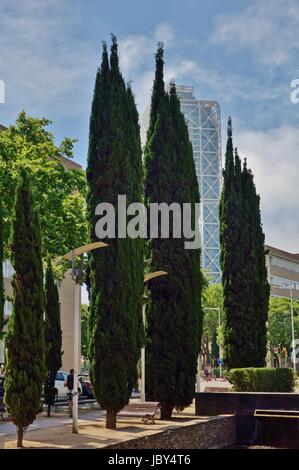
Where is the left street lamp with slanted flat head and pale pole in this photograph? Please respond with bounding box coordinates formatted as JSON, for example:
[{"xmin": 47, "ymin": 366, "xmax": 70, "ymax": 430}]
[{"xmin": 57, "ymin": 242, "xmax": 108, "ymax": 434}]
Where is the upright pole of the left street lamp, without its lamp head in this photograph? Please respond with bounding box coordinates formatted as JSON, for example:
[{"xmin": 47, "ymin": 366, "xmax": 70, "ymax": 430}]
[{"xmin": 72, "ymin": 253, "xmax": 81, "ymax": 434}]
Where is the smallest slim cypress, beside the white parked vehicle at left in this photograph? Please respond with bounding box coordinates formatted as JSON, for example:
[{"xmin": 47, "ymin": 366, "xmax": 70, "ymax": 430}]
[{"xmin": 44, "ymin": 263, "xmax": 62, "ymax": 416}]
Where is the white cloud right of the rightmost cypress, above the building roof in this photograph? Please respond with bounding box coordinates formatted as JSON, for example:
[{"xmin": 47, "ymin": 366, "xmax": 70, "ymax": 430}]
[{"xmin": 235, "ymin": 126, "xmax": 299, "ymax": 253}]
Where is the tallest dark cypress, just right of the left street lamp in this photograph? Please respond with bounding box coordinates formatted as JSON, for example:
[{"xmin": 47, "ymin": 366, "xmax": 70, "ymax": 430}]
[{"xmin": 87, "ymin": 37, "xmax": 143, "ymax": 428}]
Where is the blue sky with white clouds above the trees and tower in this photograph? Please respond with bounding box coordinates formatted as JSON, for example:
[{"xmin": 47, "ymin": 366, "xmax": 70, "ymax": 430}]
[{"xmin": 0, "ymin": 0, "xmax": 299, "ymax": 253}]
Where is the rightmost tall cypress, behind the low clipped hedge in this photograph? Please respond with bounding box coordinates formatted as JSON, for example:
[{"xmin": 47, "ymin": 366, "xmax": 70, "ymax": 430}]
[{"xmin": 220, "ymin": 118, "xmax": 269, "ymax": 369}]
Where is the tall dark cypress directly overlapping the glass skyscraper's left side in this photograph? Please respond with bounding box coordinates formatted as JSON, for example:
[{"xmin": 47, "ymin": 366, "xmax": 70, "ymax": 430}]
[{"xmin": 145, "ymin": 44, "xmax": 202, "ymax": 418}]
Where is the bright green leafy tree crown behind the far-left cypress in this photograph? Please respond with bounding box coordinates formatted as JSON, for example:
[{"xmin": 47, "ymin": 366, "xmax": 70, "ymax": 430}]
[{"xmin": 0, "ymin": 112, "xmax": 87, "ymax": 258}]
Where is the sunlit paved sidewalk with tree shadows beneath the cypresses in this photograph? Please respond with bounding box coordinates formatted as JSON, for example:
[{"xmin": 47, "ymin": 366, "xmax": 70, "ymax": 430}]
[{"xmin": 0, "ymin": 405, "xmax": 224, "ymax": 449}]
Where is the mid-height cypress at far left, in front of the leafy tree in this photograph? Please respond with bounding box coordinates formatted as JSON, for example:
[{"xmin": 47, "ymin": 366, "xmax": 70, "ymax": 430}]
[{"xmin": 4, "ymin": 170, "xmax": 46, "ymax": 447}]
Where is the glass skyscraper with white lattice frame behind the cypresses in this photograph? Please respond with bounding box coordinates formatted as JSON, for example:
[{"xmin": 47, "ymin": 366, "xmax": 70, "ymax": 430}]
[{"xmin": 176, "ymin": 85, "xmax": 222, "ymax": 282}]
